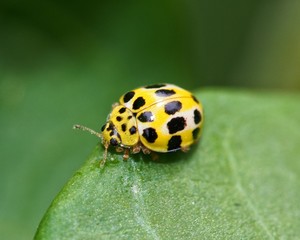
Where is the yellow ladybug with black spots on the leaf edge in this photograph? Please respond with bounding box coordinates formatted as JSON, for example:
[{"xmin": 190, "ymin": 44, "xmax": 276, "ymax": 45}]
[{"xmin": 74, "ymin": 84, "xmax": 203, "ymax": 165}]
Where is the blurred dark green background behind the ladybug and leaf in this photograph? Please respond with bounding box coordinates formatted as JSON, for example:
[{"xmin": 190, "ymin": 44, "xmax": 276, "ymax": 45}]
[{"xmin": 0, "ymin": 0, "xmax": 300, "ymax": 239}]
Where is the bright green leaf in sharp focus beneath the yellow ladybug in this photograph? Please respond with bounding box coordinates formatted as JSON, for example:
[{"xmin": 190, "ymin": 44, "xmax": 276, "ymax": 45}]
[{"xmin": 35, "ymin": 90, "xmax": 300, "ymax": 239}]
